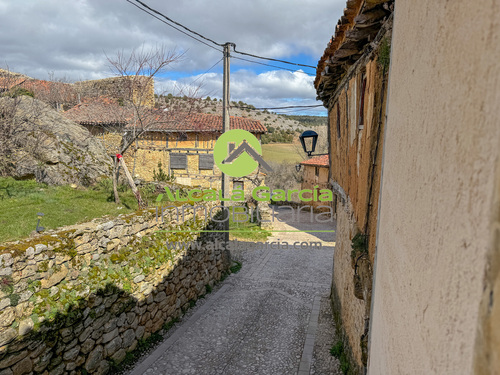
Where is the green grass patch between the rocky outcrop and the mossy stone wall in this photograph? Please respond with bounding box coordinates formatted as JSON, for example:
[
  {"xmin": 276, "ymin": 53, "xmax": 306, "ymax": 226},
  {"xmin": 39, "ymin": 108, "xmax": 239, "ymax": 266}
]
[{"xmin": 0, "ymin": 178, "xmax": 157, "ymax": 242}]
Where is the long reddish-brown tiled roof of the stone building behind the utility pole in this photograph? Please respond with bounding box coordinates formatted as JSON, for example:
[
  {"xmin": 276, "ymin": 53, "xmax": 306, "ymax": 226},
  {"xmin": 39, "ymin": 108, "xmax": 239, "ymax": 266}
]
[{"xmin": 64, "ymin": 101, "xmax": 267, "ymax": 133}]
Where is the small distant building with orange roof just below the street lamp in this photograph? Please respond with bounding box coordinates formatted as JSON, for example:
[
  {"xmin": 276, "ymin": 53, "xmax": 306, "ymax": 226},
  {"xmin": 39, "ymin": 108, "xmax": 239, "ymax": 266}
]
[{"xmin": 300, "ymin": 155, "xmax": 335, "ymax": 211}]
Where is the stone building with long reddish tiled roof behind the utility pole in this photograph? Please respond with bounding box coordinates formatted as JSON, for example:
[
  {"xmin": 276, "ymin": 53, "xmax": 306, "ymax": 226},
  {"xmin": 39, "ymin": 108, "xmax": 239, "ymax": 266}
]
[{"xmin": 65, "ymin": 98, "xmax": 267, "ymax": 190}]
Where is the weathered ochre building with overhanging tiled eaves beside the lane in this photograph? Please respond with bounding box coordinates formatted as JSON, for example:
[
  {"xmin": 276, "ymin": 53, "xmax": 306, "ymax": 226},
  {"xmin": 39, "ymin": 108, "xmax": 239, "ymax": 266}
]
[{"xmin": 315, "ymin": 0, "xmax": 393, "ymax": 372}]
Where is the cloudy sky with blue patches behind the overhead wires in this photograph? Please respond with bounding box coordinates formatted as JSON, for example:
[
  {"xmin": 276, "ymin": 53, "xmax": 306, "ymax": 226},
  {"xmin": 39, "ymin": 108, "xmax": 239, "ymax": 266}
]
[{"xmin": 0, "ymin": 0, "xmax": 345, "ymax": 115}]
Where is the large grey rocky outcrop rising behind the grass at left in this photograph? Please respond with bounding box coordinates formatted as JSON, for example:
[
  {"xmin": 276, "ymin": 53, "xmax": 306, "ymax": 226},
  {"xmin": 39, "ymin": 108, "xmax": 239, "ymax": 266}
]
[{"xmin": 0, "ymin": 96, "xmax": 112, "ymax": 186}]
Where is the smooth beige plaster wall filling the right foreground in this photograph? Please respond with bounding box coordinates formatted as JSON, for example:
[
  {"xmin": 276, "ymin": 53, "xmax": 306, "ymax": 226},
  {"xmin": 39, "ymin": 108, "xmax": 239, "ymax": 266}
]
[{"xmin": 369, "ymin": 0, "xmax": 500, "ymax": 375}]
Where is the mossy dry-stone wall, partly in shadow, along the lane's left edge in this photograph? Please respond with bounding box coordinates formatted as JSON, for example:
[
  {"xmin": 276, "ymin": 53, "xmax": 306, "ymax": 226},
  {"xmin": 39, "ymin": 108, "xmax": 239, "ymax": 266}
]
[{"xmin": 0, "ymin": 210, "xmax": 229, "ymax": 375}]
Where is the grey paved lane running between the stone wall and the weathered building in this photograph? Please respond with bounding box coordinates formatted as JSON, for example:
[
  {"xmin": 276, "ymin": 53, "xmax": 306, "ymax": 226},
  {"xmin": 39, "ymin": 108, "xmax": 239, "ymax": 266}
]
[{"xmin": 130, "ymin": 207, "xmax": 335, "ymax": 375}]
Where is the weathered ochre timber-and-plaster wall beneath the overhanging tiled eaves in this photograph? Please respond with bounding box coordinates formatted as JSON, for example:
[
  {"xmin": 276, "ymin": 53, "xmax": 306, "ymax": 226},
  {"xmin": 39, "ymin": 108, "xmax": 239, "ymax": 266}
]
[{"xmin": 328, "ymin": 28, "xmax": 391, "ymax": 372}]
